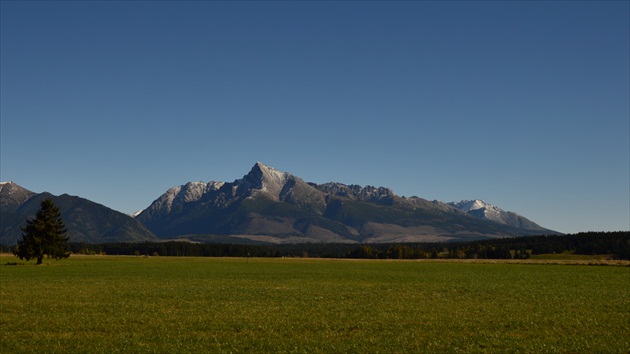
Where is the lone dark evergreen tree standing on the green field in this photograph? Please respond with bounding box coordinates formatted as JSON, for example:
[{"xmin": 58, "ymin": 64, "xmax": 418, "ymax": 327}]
[{"xmin": 14, "ymin": 199, "xmax": 70, "ymax": 264}]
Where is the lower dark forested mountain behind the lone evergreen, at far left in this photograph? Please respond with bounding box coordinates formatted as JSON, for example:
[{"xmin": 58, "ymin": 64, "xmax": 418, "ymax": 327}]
[{"xmin": 0, "ymin": 183, "xmax": 157, "ymax": 245}]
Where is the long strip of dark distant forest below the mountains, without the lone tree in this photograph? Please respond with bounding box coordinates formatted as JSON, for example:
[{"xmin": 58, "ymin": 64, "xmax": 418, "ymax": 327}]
[{"xmin": 0, "ymin": 231, "xmax": 630, "ymax": 259}]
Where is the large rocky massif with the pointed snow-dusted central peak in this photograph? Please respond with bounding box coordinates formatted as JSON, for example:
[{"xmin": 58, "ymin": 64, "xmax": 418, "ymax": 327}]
[{"xmin": 136, "ymin": 163, "xmax": 554, "ymax": 243}]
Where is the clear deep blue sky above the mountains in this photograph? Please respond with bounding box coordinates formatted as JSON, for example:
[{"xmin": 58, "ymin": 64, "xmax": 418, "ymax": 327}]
[{"xmin": 0, "ymin": 1, "xmax": 630, "ymax": 232}]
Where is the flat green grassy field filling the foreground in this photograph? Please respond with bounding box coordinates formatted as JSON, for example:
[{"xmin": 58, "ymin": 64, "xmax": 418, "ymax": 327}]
[{"xmin": 0, "ymin": 256, "xmax": 630, "ymax": 353}]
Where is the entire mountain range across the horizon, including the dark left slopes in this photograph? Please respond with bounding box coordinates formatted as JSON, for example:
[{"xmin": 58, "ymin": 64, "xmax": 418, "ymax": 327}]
[{"xmin": 0, "ymin": 162, "xmax": 557, "ymax": 244}]
